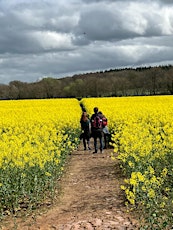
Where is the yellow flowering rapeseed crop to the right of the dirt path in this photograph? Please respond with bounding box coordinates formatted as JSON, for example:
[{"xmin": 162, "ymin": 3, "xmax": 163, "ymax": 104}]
[{"xmin": 81, "ymin": 96, "xmax": 173, "ymax": 230}]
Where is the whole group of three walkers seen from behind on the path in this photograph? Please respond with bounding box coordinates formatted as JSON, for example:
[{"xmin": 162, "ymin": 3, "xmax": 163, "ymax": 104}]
[{"xmin": 80, "ymin": 107, "xmax": 110, "ymax": 153}]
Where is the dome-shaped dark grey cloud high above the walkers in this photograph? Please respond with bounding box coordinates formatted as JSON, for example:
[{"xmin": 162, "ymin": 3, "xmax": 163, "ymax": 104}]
[{"xmin": 73, "ymin": 9, "xmax": 141, "ymax": 44}]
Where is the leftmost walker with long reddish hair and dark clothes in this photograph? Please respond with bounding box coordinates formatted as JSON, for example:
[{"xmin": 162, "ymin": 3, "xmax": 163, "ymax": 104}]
[{"xmin": 80, "ymin": 111, "xmax": 91, "ymax": 150}]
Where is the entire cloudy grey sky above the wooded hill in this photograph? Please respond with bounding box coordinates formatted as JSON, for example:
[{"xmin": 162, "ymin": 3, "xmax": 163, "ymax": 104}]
[{"xmin": 0, "ymin": 0, "xmax": 173, "ymax": 84}]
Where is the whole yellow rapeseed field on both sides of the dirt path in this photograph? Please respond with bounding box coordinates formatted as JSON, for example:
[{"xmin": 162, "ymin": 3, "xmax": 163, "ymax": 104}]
[{"xmin": 0, "ymin": 96, "xmax": 173, "ymax": 229}]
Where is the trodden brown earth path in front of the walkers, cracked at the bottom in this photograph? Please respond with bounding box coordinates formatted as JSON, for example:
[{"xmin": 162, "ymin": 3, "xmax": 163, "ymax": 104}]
[{"xmin": 1, "ymin": 143, "xmax": 139, "ymax": 230}]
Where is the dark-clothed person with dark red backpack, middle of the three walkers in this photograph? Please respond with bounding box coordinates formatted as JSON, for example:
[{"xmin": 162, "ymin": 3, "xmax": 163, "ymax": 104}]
[{"xmin": 91, "ymin": 107, "xmax": 103, "ymax": 153}]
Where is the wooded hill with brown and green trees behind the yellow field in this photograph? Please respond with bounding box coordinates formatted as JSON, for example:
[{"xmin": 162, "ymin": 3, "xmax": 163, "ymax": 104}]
[{"xmin": 0, "ymin": 65, "xmax": 173, "ymax": 99}]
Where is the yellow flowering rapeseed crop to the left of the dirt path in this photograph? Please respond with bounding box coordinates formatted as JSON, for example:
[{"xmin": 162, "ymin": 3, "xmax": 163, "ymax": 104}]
[{"xmin": 0, "ymin": 99, "xmax": 81, "ymax": 217}]
